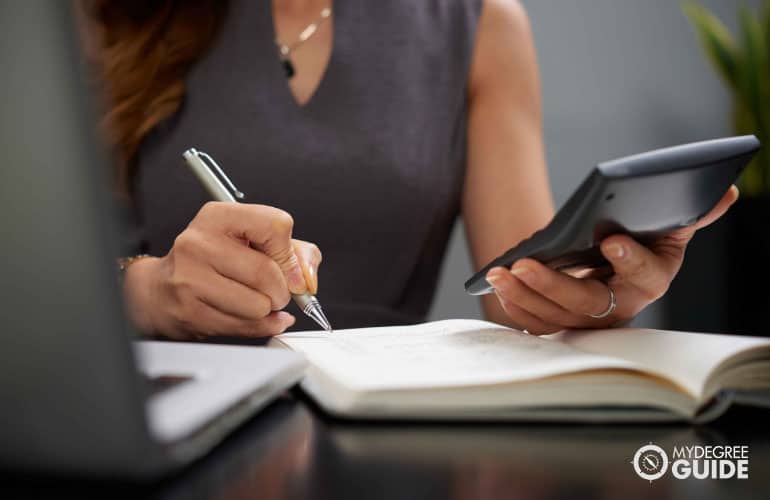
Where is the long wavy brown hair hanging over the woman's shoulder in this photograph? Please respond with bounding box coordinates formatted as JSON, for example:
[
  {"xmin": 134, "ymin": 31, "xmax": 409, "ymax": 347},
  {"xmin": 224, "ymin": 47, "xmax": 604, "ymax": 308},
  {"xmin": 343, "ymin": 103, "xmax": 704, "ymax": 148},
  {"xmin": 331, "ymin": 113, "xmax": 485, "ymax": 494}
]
[{"xmin": 77, "ymin": 0, "xmax": 227, "ymax": 195}]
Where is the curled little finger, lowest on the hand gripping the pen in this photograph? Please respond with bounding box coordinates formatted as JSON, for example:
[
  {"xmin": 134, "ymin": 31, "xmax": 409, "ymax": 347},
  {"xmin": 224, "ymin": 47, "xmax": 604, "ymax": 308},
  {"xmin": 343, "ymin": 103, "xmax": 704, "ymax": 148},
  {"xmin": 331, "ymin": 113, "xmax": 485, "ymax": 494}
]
[{"xmin": 184, "ymin": 301, "xmax": 296, "ymax": 338}]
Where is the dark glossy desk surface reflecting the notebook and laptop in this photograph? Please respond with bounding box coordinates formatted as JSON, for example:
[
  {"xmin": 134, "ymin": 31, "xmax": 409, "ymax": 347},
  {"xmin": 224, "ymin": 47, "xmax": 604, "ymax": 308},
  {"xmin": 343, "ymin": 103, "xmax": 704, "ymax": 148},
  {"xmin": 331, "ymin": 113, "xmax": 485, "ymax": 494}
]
[{"xmin": 6, "ymin": 395, "xmax": 770, "ymax": 500}]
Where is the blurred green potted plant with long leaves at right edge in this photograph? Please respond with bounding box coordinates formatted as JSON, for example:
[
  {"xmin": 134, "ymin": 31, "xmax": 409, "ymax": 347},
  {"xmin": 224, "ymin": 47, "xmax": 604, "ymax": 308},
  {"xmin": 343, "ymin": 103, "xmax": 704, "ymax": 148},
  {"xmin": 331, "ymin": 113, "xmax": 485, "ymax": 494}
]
[{"xmin": 682, "ymin": 0, "xmax": 770, "ymax": 196}]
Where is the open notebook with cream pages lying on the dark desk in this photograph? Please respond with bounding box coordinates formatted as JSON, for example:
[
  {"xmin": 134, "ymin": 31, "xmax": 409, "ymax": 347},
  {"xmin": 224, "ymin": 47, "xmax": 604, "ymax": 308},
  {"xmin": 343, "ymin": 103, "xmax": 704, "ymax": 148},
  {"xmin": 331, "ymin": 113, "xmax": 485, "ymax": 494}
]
[{"xmin": 271, "ymin": 320, "xmax": 770, "ymax": 421}]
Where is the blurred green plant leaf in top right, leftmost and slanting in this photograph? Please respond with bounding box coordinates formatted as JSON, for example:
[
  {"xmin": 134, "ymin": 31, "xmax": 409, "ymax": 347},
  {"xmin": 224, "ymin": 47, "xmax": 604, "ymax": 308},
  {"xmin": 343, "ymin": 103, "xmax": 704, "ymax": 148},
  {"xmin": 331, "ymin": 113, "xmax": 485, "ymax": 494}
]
[{"xmin": 682, "ymin": 1, "xmax": 740, "ymax": 90}]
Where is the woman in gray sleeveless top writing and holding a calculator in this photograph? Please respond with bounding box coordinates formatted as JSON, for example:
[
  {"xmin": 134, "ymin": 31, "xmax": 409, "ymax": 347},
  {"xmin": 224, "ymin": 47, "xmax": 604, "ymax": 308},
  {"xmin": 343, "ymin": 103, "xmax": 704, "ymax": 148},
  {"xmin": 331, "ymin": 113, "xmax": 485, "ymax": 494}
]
[{"xmin": 76, "ymin": 0, "xmax": 737, "ymax": 338}]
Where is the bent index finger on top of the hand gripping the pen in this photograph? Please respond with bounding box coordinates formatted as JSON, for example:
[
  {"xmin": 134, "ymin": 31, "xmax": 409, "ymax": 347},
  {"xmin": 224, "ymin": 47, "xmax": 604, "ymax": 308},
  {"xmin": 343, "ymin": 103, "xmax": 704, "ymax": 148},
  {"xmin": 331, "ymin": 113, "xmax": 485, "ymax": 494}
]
[{"xmin": 193, "ymin": 202, "xmax": 307, "ymax": 293}]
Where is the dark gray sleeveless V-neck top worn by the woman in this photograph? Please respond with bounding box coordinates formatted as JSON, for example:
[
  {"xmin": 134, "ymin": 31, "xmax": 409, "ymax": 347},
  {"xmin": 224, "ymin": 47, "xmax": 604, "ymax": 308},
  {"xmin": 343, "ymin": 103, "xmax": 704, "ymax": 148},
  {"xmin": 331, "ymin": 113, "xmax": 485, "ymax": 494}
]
[{"xmin": 134, "ymin": 0, "xmax": 481, "ymax": 330}]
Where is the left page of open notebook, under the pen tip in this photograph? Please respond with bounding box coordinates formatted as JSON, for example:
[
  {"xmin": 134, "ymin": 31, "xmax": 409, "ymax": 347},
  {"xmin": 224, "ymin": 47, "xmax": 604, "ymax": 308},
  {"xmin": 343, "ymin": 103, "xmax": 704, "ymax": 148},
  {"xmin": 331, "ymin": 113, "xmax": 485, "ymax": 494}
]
[{"xmin": 276, "ymin": 320, "xmax": 633, "ymax": 390}]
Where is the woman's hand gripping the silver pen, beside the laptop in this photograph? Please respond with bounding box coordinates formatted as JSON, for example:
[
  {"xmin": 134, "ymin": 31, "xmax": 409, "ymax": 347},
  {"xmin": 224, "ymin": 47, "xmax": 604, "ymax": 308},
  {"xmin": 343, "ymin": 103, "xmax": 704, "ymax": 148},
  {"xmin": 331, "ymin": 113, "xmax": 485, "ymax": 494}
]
[{"xmin": 123, "ymin": 202, "xmax": 321, "ymax": 339}]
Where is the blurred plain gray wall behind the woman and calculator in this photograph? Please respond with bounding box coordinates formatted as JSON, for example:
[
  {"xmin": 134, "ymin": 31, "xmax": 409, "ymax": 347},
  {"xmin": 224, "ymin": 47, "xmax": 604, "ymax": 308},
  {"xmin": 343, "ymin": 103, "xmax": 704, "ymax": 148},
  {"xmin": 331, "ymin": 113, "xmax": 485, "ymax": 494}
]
[{"xmin": 431, "ymin": 0, "xmax": 758, "ymax": 328}]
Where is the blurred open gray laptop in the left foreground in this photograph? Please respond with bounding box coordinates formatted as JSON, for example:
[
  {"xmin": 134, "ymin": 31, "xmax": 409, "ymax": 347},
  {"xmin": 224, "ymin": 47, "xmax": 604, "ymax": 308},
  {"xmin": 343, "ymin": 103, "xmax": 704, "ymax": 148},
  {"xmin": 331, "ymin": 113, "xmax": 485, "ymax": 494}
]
[{"xmin": 0, "ymin": 1, "xmax": 305, "ymax": 478}]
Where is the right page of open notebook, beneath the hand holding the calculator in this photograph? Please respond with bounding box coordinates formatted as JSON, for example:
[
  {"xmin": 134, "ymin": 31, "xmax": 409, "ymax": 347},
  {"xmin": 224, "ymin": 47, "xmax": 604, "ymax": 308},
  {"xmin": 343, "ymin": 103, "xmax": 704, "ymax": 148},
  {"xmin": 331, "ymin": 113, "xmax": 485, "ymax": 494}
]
[{"xmin": 547, "ymin": 328, "xmax": 770, "ymax": 397}]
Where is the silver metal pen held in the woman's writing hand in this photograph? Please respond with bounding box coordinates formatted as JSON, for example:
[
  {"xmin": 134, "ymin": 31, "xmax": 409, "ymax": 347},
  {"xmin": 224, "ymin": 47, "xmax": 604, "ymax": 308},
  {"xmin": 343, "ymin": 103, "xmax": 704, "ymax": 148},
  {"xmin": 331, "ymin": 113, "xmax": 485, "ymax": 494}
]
[{"xmin": 182, "ymin": 148, "xmax": 332, "ymax": 332}]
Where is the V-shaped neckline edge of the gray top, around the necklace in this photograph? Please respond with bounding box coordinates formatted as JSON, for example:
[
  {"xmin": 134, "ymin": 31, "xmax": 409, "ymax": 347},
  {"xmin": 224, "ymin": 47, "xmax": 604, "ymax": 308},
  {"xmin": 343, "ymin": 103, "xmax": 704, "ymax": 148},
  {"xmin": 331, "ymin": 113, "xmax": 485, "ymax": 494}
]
[{"xmin": 267, "ymin": 0, "xmax": 343, "ymax": 111}]
